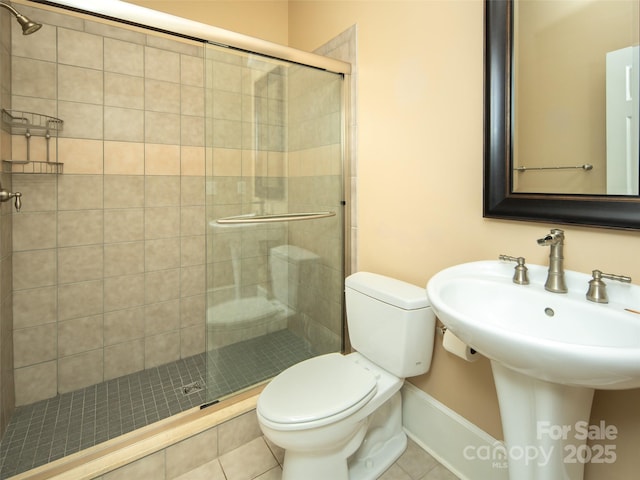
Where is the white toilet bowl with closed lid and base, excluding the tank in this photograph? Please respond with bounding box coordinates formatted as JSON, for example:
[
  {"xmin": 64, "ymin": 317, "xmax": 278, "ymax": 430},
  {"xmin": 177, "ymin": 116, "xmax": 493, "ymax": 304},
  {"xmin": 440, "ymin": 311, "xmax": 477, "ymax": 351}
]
[{"xmin": 257, "ymin": 352, "xmax": 406, "ymax": 479}]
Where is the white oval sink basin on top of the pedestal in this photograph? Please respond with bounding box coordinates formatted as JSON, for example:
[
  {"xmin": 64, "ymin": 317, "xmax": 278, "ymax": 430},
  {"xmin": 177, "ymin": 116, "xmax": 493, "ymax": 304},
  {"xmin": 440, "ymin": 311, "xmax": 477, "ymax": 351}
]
[{"xmin": 427, "ymin": 261, "xmax": 640, "ymax": 390}]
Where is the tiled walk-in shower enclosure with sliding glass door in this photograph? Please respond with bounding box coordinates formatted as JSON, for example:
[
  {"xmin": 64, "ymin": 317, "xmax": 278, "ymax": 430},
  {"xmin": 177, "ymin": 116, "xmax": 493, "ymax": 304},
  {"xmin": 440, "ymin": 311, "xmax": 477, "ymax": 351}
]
[{"xmin": 0, "ymin": 0, "xmax": 346, "ymax": 478}]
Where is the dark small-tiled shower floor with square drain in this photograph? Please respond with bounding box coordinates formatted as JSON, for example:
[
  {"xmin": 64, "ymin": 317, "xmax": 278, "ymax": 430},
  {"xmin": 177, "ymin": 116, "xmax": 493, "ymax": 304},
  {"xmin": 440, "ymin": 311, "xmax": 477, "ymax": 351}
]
[{"xmin": 0, "ymin": 330, "xmax": 313, "ymax": 478}]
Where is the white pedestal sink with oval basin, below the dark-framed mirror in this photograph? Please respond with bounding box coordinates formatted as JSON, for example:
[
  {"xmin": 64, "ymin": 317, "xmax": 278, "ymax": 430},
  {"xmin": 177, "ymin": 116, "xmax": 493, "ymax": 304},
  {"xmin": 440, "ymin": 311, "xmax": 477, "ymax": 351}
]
[{"xmin": 427, "ymin": 261, "xmax": 640, "ymax": 480}]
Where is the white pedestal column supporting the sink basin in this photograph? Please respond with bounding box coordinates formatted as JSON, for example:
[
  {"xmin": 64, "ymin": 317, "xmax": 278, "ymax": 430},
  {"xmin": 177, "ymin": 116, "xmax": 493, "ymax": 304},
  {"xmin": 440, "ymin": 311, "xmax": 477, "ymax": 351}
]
[{"xmin": 491, "ymin": 360, "xmax": 594, "ymax": 480}]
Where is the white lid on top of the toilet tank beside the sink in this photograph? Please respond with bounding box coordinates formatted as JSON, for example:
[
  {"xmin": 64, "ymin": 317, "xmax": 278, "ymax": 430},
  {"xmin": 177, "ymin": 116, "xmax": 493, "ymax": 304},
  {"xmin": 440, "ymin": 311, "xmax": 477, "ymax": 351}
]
[{"xmin": 345, "ymin": 272, "xmax": 429, "ymax": 310}]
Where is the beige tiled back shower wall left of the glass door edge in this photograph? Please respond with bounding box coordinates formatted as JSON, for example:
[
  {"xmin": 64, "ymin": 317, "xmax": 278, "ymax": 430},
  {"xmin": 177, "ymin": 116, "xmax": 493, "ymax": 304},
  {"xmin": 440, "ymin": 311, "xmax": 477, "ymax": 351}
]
[{"xmin": 9, "ymin": 6, "xmax": 205, "ymax": 405}]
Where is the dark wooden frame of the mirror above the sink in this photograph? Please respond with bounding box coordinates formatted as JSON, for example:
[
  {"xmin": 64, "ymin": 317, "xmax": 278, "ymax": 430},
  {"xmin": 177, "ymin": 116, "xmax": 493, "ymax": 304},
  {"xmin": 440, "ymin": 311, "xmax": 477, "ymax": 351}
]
[{"xmin": 483, "ymin": 0, "xmax": 640, "ymax": 230}]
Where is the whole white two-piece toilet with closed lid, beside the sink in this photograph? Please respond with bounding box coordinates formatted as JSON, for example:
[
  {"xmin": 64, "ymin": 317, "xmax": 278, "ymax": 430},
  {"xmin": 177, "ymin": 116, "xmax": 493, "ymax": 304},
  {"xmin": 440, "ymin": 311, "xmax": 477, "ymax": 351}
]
[{"xmin": 257, "ymin": 272, "xmax": 435, "ymax": 480}]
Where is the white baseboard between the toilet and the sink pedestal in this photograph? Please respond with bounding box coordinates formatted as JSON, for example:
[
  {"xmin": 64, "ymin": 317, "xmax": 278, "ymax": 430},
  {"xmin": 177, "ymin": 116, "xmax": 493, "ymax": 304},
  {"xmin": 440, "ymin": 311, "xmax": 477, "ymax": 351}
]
[{"xmin": 402, "ymin": 382, "xmax": 509, "ymax": 480}]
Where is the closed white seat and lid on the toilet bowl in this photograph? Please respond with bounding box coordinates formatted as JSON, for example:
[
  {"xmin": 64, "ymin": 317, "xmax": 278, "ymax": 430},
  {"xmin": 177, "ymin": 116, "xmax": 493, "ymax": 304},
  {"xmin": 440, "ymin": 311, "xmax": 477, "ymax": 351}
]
[{"xmin": 257, "ymin": 353, "xmax": 377, "ymax": 430}]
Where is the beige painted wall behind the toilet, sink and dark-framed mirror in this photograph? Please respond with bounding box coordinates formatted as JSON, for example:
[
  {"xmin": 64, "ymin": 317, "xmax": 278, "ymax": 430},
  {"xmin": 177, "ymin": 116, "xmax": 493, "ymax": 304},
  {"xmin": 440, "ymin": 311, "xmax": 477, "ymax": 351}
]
[{"xmin": 289, "ymin": 0, "xmax": 640, "ymax": 479}]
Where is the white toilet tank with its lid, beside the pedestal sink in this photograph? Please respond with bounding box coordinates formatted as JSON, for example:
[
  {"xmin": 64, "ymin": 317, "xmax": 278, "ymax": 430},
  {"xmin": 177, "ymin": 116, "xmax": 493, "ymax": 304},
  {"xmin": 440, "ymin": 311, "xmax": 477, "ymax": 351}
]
[{"xmin": 345, "ymin": 272, "xmax": 436, "ymax": 378}]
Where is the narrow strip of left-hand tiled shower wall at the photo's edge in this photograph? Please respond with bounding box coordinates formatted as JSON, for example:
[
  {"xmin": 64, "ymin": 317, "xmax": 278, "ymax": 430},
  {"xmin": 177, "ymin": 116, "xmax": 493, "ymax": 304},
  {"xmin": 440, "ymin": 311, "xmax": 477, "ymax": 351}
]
[{"xmin": 0, "ymin": 5, "xmax": 15, "ymax": 436}]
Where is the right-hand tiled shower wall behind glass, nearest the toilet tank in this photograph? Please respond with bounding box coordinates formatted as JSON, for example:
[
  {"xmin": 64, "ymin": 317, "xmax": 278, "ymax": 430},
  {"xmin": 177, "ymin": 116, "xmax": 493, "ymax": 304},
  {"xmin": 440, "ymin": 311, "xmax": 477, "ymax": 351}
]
[{"xmin": 288, "ymin": 67, "xmax": 344, "ymax": 352}]
